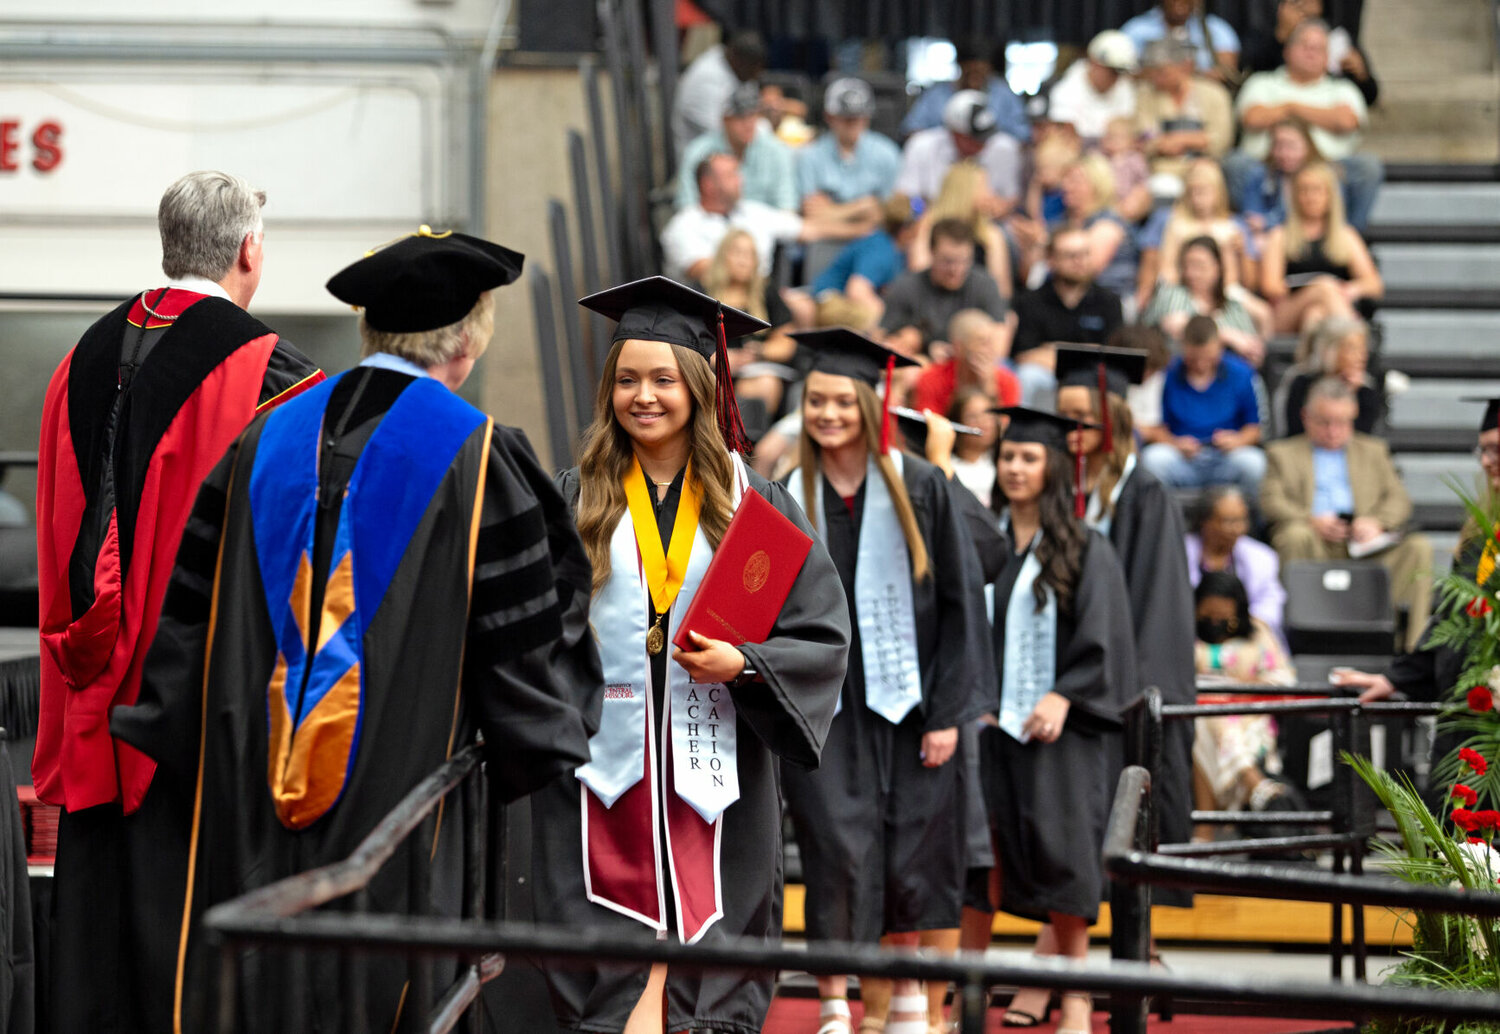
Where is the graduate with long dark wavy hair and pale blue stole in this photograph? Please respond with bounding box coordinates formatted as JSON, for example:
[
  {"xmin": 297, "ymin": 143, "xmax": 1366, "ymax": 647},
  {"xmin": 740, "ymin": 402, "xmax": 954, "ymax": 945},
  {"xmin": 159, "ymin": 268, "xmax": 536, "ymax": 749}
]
[{"xmin": 986, "ymin": 407, "xmax": 1136, "ymax": 1034}]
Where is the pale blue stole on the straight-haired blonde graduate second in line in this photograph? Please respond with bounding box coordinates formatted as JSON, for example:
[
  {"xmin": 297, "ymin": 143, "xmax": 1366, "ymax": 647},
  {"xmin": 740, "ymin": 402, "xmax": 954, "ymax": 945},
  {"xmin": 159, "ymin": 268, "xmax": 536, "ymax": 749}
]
[{"xmin": 789, "ymin": 452, "xmax": 923, "ymax": 725}]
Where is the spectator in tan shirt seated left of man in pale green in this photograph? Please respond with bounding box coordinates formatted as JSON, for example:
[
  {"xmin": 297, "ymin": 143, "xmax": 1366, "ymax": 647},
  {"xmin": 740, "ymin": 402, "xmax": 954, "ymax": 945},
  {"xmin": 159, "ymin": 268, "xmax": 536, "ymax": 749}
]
[{"xmin": 1136, "ymin": 39, "xmax": 1235, "ymax": 186}]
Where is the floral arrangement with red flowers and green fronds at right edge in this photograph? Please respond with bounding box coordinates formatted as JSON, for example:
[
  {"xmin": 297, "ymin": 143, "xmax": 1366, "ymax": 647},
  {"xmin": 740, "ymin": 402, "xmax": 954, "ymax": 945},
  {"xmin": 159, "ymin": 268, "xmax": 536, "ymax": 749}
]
[{"xmin": 1347, "ymin": 485, "xmax": 1500, "ymax": 1034}]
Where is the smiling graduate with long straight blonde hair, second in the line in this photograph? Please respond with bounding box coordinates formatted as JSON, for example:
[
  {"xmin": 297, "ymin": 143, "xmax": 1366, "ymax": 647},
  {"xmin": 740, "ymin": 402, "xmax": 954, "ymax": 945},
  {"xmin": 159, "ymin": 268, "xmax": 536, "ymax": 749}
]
[{"xmin": 783, "ymin": 329, "xmax": 995, "ymax": 1034}]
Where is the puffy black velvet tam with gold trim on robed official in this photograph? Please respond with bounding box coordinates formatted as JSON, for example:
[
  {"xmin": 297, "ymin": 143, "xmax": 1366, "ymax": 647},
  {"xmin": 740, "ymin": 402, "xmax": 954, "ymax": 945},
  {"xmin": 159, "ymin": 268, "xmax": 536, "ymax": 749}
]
[{"xmin": 327, "ymin": 227, "xmax": 527, "ymax": 333}]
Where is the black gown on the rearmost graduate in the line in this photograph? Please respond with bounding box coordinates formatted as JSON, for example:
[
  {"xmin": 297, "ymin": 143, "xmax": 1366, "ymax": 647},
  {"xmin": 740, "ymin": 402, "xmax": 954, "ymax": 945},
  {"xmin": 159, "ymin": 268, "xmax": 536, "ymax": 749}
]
[{"xmin": 1110, "ymin": 464, "xmax": 1197, "ymax": 908}]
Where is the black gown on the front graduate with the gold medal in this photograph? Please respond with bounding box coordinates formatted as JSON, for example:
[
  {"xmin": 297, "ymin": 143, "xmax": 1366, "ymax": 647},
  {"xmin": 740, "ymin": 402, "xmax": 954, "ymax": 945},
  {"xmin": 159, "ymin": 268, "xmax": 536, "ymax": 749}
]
[{"xmin": 531, "ymin": 470, "xmax": 849, "ymax": 1034}]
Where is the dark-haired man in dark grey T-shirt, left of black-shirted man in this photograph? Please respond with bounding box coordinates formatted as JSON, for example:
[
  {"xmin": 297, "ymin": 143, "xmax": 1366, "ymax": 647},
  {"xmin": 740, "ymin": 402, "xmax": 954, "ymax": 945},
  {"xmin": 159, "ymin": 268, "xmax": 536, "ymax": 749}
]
[{"xmin": 881, "ymin": 219, "xmax": 1010, "ymax": 354}]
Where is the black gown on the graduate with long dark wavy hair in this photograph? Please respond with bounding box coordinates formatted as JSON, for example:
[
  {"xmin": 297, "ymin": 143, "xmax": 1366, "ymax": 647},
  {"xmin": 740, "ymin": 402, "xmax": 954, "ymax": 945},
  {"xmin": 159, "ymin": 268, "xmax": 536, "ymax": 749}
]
[{"xmin": 984, "ymin": 531, "xmax": 1136, "ymax": 923}]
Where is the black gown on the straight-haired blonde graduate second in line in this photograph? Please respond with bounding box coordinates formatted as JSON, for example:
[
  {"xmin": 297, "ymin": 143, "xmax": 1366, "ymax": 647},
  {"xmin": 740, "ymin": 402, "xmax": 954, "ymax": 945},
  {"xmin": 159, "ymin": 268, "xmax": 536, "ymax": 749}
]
[{"xmin": 783, "ymin": 456, "xmax": 996, "ymax": 941}]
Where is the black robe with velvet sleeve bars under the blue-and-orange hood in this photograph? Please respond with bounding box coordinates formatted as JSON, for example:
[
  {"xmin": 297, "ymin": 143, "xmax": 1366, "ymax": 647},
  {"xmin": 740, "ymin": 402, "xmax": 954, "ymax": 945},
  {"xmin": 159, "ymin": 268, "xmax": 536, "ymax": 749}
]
[{"xmin": 111, "ymin": 368, "xmax": 602, "ymax": 1031}]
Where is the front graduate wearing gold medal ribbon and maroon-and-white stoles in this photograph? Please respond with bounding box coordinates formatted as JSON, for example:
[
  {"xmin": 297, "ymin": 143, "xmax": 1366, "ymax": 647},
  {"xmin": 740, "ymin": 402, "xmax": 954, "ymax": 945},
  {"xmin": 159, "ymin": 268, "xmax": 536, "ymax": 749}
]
[{"xmin": 531, "ymin": 276, "xmax": 849, "ymax": 1034}]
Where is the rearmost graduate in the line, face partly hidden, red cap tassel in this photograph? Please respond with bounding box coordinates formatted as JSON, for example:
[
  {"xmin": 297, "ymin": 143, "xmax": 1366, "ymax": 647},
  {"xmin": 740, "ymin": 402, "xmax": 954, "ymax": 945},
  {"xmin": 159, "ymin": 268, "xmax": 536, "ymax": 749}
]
[{"xmin": 1058, "ymin": 345, "xmax": 1197, "ymax": 908}]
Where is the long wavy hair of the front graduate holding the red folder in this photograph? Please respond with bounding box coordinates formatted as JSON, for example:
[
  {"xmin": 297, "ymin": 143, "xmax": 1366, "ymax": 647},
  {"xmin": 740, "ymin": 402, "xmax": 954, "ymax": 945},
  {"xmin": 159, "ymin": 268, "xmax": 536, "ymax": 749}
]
[{"xmin": 575, "ymin": 341, "xmax": 735, "ymax": 596}]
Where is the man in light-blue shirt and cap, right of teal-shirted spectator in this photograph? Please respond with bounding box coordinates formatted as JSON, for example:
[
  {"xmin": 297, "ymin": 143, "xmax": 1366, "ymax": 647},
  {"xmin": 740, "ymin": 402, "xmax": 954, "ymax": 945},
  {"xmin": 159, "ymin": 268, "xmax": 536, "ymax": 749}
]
[{"xmin": 797, "ymin": 78, "xmax": 902, "ymax": 228}]
